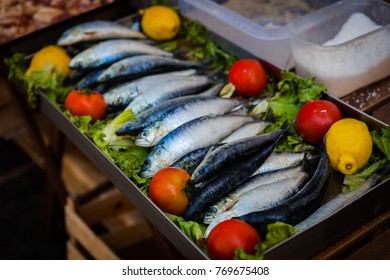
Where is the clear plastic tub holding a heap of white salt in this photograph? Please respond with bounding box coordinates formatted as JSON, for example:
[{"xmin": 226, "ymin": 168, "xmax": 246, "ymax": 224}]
[{"xmin": 288, "ymin": 0, "xmax": 390, "ymax": 98}]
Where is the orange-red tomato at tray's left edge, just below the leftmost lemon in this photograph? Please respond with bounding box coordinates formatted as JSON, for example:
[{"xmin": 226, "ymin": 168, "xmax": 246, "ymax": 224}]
[{"xmin": 65, "ymin": 89, "xmax": 107, "ymax": 122}]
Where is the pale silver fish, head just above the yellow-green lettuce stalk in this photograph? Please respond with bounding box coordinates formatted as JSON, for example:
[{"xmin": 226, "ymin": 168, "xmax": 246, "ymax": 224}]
[{"xmin": 125, "ymin": 75, "xmax": 211, "ymax": 115}]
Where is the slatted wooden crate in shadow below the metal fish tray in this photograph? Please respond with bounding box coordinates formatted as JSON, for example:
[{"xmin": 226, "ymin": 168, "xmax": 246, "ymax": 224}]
[{"xmin": 65, "ymin": 192, "xmax": 152, "ymax": 260}]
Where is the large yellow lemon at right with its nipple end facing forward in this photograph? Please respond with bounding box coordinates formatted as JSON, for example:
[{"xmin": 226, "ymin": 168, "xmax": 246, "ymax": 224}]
[{"xmin": 326, "ymin": 118, "xmax": 373, "ymax": 175}]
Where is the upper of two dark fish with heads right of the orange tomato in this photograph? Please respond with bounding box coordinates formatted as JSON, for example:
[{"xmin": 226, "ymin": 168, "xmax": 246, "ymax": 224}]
[{"xmin": 191, "ymin": 129, "xmax": 284, "ymax": 184}]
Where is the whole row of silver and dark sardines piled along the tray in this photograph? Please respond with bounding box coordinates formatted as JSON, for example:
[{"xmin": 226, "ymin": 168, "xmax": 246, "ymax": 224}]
[{"xmin": 58, "ymin": 18, "xmax": 336, "ymax": 236}]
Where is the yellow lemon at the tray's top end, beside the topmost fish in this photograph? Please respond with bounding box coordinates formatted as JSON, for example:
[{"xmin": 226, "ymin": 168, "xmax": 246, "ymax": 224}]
[{"xmin": 140, "ymin": 5, "xmax": 180, "ymax": 41}]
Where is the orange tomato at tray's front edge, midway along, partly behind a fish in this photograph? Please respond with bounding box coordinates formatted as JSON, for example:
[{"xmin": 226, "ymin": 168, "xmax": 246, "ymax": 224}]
[{"xmin": 149, "ymin": 167, "xmax": 190, "ymax": 216}]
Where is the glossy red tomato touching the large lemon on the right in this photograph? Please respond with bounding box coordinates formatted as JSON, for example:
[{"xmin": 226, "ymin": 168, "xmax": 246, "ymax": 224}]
[{"xmin": 295, "ymin": 100, "xmax": 343, "ymax": 145}]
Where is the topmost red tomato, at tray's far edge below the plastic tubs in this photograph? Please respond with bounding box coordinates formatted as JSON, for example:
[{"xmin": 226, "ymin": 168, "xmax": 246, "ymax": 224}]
[{"xmin": 228, "ymin": 58, "xmax": 267, "ymax": 96}]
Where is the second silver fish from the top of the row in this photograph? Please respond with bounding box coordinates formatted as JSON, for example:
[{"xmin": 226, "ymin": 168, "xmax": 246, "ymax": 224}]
[{"xmin": 69, "ymin": 39, "xmax": 173, "ymax": 69}]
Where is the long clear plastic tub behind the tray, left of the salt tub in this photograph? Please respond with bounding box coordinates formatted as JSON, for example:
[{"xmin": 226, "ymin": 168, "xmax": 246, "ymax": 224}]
[{"xmin": 179, "ymin": 0, "xmax": 335, "ymax": 69}]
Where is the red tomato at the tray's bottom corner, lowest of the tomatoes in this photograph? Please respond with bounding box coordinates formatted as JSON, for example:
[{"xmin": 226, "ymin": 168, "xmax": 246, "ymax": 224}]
[{"xmin": 206, "ymin": 219, "xmax": 261, "ymax": 260}]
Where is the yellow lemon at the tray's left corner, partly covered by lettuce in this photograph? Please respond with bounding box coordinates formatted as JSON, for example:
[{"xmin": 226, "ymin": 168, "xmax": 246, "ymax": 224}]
[{"xmin": 26, "ymin": 46, "xmax": 71, "ymax": 76}]
